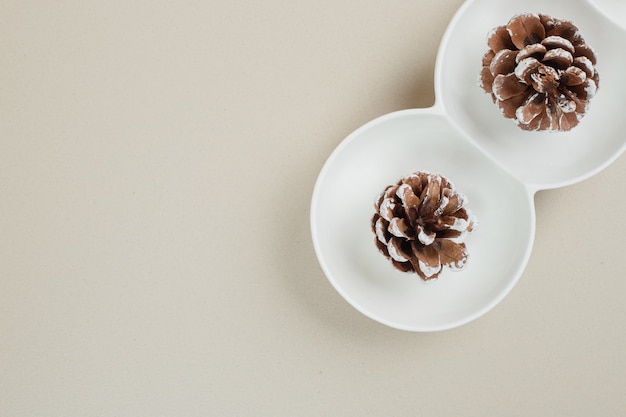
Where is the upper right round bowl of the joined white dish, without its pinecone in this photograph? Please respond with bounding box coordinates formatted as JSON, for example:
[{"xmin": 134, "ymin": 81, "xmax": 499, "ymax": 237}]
[{"xmin": 435, "ymin": 0, "xmax": 626, "ymax": 189}]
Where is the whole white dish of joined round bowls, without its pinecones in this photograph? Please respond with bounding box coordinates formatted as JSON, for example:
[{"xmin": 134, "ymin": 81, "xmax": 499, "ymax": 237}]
[{"xmin": 311, "ymin": 0, "xmax": 626, "ymax": 331}]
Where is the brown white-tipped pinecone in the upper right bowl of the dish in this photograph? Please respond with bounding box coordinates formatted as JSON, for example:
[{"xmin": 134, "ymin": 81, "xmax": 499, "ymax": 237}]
[{"xmin": 480, "ymin": 13, "xmax": 599, "ymax": 131}]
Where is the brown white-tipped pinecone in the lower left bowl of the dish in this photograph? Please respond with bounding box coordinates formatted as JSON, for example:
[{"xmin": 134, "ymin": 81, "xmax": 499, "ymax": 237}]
[{"xmin": 372, "ymin": 171, "xmax": 475, "ymax": 281}]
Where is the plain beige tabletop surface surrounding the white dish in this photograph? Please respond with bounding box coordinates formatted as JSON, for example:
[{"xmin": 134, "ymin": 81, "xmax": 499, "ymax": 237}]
[{"xmin": 0, "ymin": 0, "xmax": 626, "ymax": 417}]
